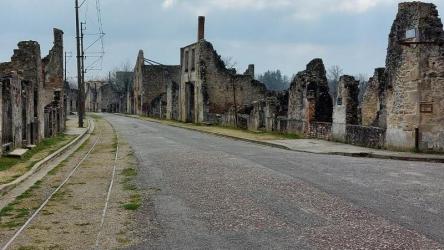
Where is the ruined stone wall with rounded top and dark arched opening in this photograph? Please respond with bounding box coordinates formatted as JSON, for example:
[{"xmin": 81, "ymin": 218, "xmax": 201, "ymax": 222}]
[{"xmin": 288, "ymin": 59, "xmax": 333, "ymax": 133}]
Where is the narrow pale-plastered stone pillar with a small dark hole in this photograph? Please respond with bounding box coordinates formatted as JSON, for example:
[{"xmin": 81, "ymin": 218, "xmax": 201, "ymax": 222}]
[{"xmin": 332, "ymin": 75, "xmax": 359, "ymax": 141}]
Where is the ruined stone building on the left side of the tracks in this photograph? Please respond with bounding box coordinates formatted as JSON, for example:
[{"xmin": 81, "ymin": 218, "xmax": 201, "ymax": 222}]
[{"xmin": 0, "ymin": 29, "xmax": 65, "ymax": 153}]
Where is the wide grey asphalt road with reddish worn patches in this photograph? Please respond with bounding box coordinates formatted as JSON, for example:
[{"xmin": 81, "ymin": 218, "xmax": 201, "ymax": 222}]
[{"xmin": 104, "ymin": 115, "xmax": 444, "ymax": 249}]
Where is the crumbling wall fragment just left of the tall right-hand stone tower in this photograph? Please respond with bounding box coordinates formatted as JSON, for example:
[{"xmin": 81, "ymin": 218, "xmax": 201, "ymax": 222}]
[{"xmin": 361, "ymin": 68, "xmax": 387, "ymax": 128}]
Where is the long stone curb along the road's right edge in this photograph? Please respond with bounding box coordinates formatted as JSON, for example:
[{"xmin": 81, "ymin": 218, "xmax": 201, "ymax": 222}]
[{"xmin": 116, "ymin": 114, "xmax": 444, "ymax": 163}]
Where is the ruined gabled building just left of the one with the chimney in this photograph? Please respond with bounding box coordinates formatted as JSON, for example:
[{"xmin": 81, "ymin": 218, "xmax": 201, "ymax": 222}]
[{"xmin": 132, "ymin": 50, "xmax": 180, "ymax": 119}]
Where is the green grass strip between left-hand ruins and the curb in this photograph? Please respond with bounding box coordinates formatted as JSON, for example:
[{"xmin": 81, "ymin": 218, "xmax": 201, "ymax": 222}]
[{"xmin": 0, "ymin": 134, "xmax": 74, "ymax": 171}]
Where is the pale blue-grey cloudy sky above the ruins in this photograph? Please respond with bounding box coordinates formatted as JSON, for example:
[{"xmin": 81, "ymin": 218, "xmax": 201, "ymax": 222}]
[{"xmin": 0, "ymin": 0, "xmax": 444, "ymax": 80}]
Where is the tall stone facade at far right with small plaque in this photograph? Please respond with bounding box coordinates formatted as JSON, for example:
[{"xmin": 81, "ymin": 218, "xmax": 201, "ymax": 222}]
[{"xmin": 386, "ymin": 2, "xmax": 444, "ymax": 151}]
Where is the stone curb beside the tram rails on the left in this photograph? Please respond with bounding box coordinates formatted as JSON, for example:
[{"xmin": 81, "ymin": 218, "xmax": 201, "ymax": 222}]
[{"xmin": 0, "ymin": 119, "xmax": 94, "ymax": 196}]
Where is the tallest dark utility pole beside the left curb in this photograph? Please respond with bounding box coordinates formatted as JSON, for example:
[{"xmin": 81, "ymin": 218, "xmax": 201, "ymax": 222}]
[{"xmin": 75, "ymin": 0, "xmax": 85, "ymax": 128}]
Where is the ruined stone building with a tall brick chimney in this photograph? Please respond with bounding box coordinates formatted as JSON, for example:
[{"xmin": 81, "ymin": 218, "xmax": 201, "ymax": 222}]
[{"xmin": 179, "ymin": 17, "xmax": 267, "ymax": 123}]
